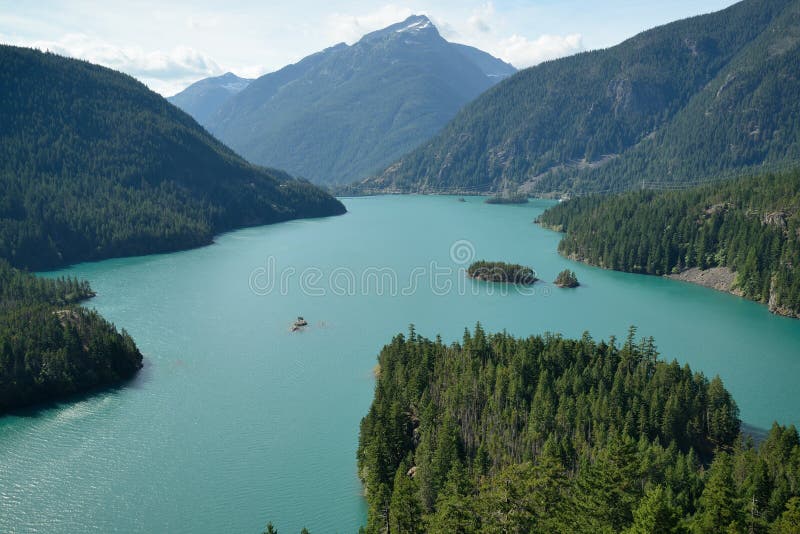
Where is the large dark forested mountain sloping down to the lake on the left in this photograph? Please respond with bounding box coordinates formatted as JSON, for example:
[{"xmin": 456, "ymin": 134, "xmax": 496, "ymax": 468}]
[{"xmin": 0, "ymin": 46, "xmax": 344, "ymax": 269}]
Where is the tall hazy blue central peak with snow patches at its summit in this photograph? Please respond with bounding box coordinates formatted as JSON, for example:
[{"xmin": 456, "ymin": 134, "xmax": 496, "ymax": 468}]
[{"xmin": 198, "ymin": 16, "xmax": 514, "ymax": 184}]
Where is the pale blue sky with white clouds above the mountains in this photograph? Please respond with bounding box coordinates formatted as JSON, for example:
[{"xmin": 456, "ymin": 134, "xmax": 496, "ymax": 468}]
[{"xmin": 0, "ymin": 0, "xmax": 734, "ymax": 96}]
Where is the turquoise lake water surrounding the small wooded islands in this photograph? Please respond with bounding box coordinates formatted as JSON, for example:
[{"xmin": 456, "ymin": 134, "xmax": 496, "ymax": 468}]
[{"xmin": 0, "ymin": 196, "xmax": 800, "ymax": 534}]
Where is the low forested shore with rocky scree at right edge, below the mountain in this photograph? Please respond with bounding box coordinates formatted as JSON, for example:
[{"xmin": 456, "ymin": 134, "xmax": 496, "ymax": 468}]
[{"xmin": 539, "ymin": 170, "xmax": 800, "ymax": 317}]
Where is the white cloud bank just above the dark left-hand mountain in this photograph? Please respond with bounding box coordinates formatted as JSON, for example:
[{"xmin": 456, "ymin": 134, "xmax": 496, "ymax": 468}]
[{"xmin": 4, "ymin": 33, "xmax": 223, "ymax": 95}]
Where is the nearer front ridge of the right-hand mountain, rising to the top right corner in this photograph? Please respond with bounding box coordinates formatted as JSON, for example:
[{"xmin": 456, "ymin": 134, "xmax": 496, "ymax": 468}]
[{"xmin": 552, "ymin": 2, "xmax": 800, "ymax": 195}]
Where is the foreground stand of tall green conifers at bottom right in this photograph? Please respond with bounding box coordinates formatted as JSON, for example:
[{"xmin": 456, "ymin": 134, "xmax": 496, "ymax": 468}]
[{"xmin": 358, "ymin": 326, "xmax": 800, "ymax": 534}]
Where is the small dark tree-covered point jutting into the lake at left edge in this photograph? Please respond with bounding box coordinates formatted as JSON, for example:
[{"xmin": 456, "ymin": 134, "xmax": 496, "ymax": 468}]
[{"xmin": 0, "ymin": 260, "xmax": 142, "ymax": 414}]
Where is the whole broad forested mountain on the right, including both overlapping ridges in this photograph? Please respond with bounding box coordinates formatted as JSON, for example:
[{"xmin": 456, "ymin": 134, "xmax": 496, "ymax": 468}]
[{"xmin": 357, "ymin": 0, "xmax": 800, "ymax": 193}]
